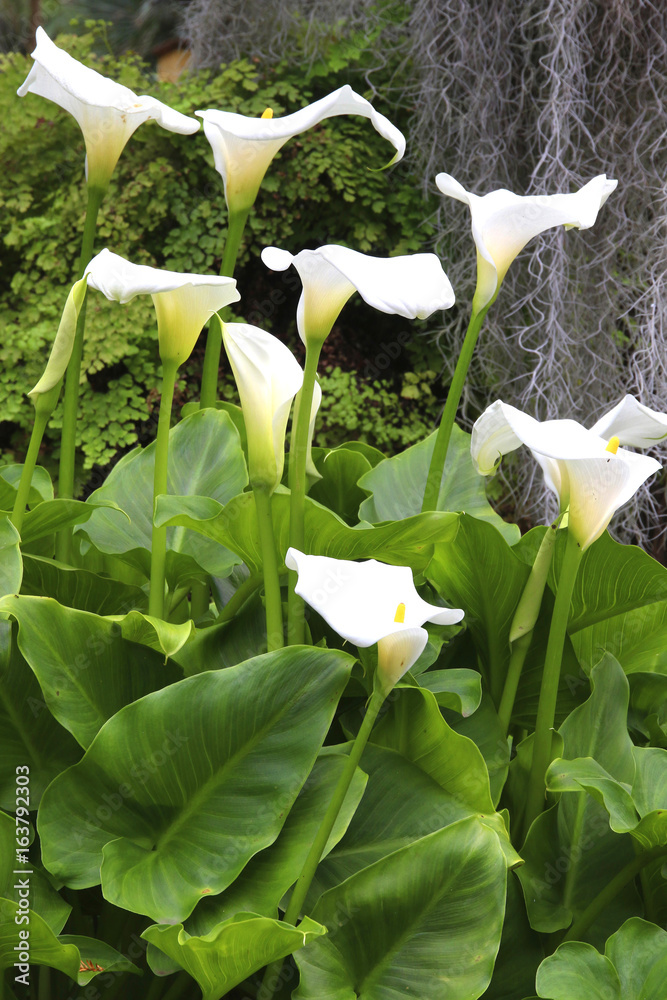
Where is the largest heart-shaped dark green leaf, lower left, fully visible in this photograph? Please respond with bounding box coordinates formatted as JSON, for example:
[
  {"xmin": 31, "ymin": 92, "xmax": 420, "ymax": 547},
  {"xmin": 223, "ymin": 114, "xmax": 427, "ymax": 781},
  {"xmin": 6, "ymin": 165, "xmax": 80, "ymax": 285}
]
[{"xmin": 38, "ymin": 647, "xmax": 354, "ymax": 923}]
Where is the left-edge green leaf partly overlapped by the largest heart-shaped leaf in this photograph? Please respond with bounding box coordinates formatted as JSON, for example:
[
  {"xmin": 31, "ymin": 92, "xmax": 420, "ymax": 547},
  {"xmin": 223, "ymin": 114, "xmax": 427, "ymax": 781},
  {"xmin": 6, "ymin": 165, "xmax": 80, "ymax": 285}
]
[{"xmin": 0, "ymin": 597, "xmax": 181, "ymax": 748}]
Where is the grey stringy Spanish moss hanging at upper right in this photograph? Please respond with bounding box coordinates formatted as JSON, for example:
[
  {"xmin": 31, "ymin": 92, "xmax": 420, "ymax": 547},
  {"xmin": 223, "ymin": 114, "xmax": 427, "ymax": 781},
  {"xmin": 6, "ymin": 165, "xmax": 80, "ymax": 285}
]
[{"xmin": 179, "ymin": 0, "xmax": 667, "ymax": 554}]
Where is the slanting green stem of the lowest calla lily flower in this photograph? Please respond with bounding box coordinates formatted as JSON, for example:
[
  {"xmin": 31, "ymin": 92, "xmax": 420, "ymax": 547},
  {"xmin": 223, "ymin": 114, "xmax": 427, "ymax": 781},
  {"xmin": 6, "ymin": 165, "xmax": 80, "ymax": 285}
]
[{"xmin": 262, "ymin": 688, "xmax": 386, "ymax": 1000}]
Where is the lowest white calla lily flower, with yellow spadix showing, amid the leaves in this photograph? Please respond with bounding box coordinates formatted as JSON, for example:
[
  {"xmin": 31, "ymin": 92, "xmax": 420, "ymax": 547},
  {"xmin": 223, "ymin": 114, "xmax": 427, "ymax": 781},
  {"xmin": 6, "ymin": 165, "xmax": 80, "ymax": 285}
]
[{"xmin": 285, "ymin": 548, "xmax": 464, "ymax": 690}]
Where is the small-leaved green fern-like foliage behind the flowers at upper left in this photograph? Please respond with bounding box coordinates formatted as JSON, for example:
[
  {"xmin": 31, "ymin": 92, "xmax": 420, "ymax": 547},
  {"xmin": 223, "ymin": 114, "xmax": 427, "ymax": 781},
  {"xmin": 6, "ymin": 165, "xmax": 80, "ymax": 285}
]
[{"xmin": 0, "ymin": 22, "xmax": 444, "ymax": 479}]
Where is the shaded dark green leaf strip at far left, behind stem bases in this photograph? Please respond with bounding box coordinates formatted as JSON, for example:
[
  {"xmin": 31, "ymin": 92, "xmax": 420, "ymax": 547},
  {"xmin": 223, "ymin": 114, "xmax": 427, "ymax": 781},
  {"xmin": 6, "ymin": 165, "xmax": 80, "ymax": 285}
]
[{"xmin": 21, "ymin": 553, "xmax": 148, "ymax": 615}]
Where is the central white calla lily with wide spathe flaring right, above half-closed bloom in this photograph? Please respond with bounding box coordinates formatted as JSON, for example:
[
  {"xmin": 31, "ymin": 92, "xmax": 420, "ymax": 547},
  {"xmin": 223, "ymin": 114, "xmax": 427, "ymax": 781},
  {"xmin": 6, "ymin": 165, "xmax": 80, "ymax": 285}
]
[{"xmin": 262, "ymin": 245, "xmax": 455, "ymax": 343}]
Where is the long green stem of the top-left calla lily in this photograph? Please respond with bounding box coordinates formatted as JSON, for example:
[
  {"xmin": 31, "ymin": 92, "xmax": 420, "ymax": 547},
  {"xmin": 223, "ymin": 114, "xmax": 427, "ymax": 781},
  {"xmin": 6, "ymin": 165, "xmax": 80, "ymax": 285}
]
[{"xmin": 56, "ymin": 186, "xmax": 106, "ymax": 562}]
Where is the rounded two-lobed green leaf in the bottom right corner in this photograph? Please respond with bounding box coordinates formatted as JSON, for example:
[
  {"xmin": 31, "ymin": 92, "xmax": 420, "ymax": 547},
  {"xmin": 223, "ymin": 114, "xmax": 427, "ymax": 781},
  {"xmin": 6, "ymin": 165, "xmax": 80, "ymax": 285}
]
[{"xmin": 536, "ymin": 917, "xmax": 667, "ymax": 1000}]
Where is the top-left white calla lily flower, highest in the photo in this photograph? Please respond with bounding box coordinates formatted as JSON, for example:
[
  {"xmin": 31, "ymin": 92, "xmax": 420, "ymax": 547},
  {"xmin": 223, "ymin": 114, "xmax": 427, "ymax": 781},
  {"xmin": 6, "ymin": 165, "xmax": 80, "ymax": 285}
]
[{"xmin": 18, "ymin": 28, "xmax": 199, "ymax": 187}]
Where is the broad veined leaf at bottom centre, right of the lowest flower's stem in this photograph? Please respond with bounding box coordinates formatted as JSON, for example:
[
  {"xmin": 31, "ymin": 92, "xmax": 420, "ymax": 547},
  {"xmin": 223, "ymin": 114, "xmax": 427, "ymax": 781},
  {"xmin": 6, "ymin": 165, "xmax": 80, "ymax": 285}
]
[{"xmin": 293, "ymin": 818, "xmax": 506, "ymax": 1000}]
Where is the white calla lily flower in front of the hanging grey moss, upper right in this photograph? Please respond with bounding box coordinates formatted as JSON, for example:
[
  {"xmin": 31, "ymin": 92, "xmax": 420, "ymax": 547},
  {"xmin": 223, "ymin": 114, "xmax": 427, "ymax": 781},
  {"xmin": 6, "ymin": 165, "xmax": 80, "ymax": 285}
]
[{"xmin": 435, "ymin": 174, "xmax": 618, "ymax": 312}]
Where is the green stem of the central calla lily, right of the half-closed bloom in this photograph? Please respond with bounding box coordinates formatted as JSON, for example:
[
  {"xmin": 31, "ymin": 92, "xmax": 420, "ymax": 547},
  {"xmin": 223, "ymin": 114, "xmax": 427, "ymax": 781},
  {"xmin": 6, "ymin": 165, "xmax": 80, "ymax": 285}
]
[{"xmin": 287, "ymin": 342, "xmax": 323, "ymax": 646}]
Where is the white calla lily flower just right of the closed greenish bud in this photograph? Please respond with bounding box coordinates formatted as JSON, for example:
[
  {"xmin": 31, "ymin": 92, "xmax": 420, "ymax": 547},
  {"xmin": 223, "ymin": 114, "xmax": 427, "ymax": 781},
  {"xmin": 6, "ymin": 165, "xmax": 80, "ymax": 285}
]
[{"xmin": 85, "ymin": 250, "xmax": 241, "ymax": 365}]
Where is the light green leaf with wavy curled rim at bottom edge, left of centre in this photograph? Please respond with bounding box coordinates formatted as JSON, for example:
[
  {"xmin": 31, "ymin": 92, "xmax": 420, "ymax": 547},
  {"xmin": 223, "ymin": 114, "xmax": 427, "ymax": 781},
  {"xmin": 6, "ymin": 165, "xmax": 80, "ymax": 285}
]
[{"xmin": 141, "ymin": 913, "xmax": 326, "ymax": 1000}]
